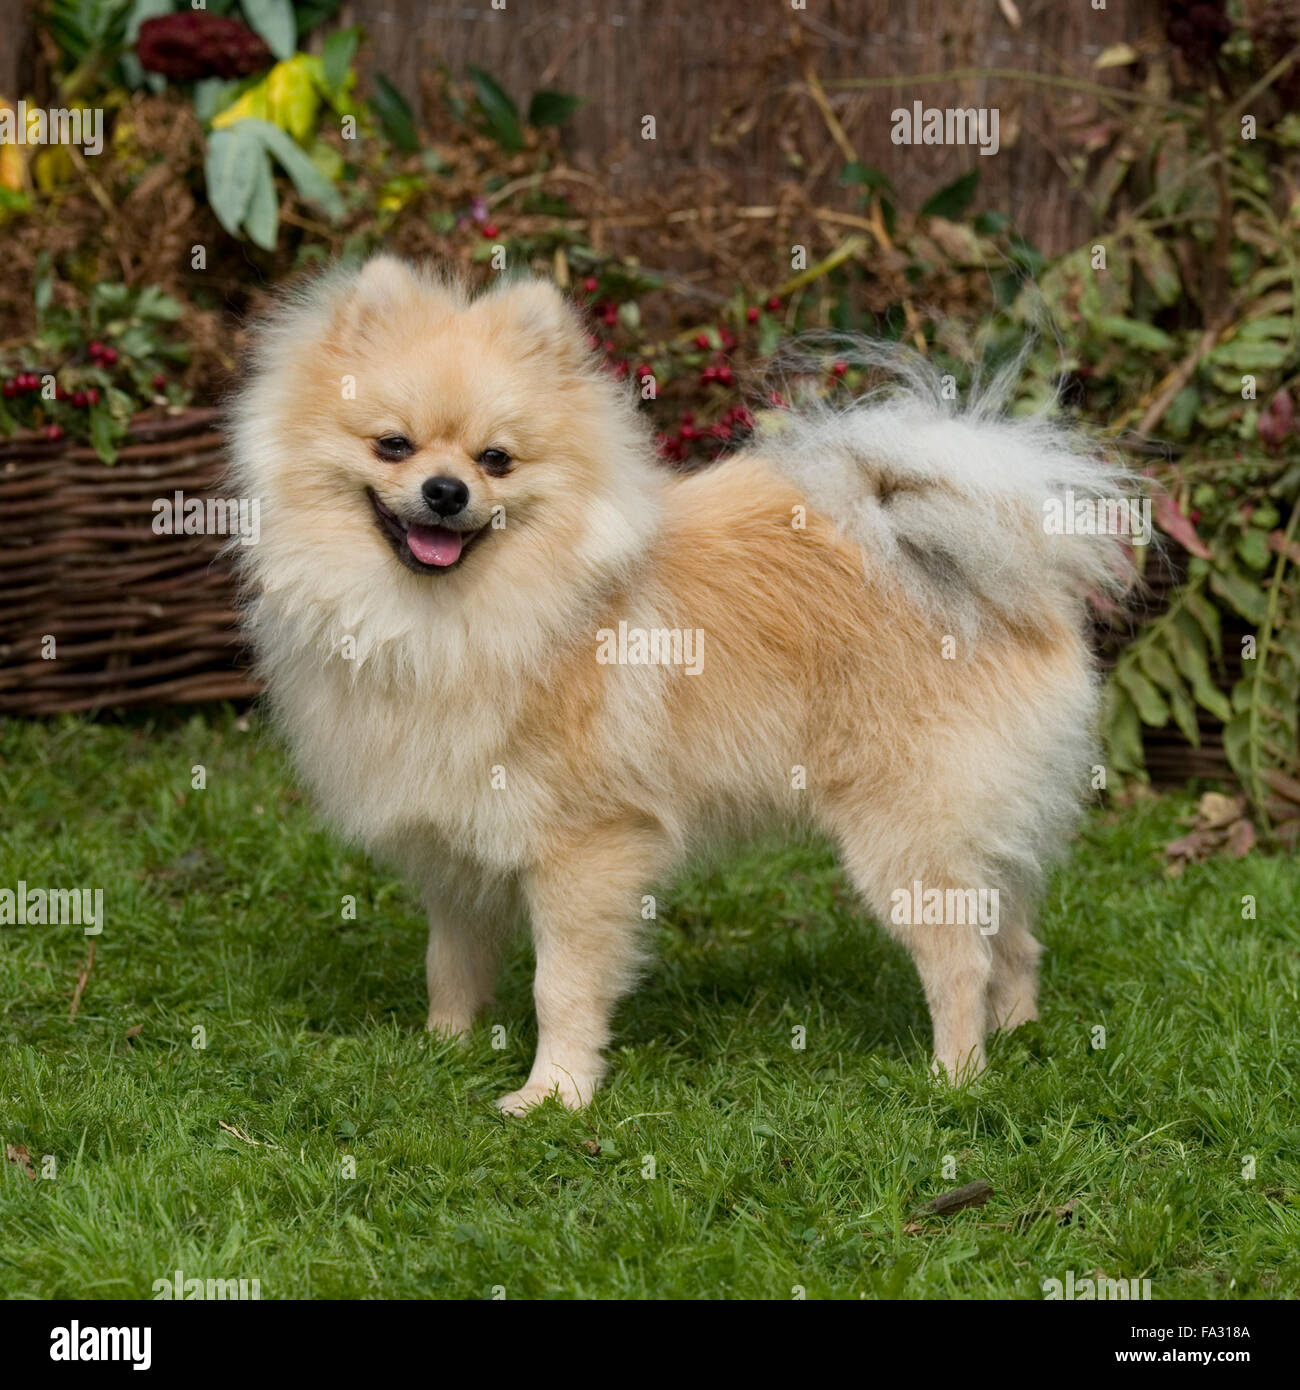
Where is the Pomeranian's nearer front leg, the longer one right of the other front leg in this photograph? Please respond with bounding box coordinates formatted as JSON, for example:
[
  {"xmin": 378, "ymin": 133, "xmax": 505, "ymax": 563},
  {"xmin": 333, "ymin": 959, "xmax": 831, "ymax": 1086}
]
[{"xmin": 496, "ymin": 819, "xmax": 667, "ymax": 1115}]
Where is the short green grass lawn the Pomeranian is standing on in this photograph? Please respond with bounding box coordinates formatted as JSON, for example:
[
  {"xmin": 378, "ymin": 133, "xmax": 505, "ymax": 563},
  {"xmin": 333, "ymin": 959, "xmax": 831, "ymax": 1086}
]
[{"xmin": 0, "ymin": 713, "xmax": 1300, "ymax": 1298}]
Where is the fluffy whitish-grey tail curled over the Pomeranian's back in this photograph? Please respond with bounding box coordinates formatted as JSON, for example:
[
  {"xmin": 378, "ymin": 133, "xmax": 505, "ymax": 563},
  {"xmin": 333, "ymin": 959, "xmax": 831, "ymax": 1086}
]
[{"xmin": 763, "ymin": 345, "xmax": 1150, "ymax": 632}]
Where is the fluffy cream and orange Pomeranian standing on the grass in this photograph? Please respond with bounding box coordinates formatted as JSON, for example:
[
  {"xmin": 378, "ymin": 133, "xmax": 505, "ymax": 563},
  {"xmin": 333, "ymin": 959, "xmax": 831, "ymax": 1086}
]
[{"xmin": 231, "ymin": 257, "xmax": 1125, "ymax": 1113}]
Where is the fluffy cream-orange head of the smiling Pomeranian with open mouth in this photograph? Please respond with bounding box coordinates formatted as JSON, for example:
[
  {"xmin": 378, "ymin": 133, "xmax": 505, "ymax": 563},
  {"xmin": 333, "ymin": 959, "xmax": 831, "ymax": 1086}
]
[{"xmin": 234, "ymin": 256, "xmax": 656, "ymax": 669}]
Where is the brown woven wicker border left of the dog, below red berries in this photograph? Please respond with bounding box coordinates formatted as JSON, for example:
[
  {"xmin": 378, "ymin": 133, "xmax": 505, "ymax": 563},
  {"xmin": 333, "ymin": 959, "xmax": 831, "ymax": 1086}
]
[{"xmin": 0, "ymin": 410, "xmax": 257, "ymax": 714}]
